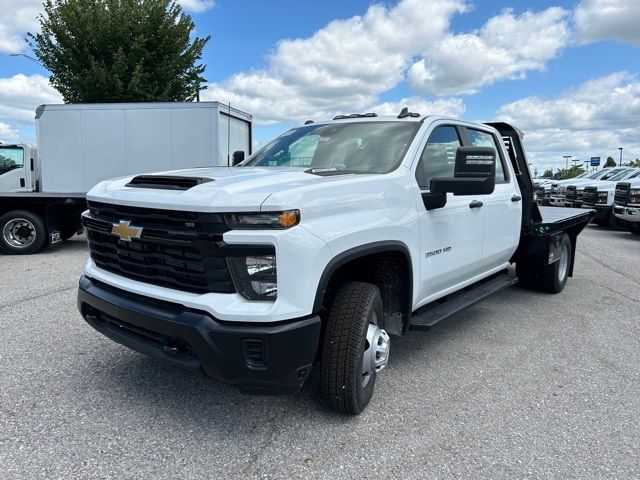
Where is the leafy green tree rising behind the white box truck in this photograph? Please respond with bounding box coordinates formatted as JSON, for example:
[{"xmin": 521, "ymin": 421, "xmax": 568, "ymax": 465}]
[{"xmin": 27, "ymin": 0, "xmax": 210, "ymax": 103}]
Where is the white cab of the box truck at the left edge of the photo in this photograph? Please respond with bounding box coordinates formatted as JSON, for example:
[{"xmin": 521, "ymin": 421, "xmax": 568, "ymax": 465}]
[{"xmin": 0, "ymin": 143, "xmax": 38, "ymax": 193}]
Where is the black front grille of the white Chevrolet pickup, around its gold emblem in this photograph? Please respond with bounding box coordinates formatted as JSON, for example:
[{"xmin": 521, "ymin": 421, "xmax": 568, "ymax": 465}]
[{"xmin": 83, "ymin": 202, "xmax": 251, "ymax": 293}]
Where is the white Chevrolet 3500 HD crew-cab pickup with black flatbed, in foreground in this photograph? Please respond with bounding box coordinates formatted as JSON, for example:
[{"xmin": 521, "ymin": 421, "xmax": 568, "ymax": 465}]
[{"xmin": 78, "ymin": 109, "xmax": 592, "ymax": 414}]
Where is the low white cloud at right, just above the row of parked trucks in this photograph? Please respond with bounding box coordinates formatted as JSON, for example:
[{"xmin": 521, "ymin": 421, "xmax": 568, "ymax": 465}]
[{"xmin": 496, "ymin": 72, "xmax": 640, "ymax": 167}]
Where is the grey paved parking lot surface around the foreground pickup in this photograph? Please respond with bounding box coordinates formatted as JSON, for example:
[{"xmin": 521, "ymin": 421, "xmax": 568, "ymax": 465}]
[{"xmin": 0, "ymin": 226, "xmax": 640, "ymax": 479}]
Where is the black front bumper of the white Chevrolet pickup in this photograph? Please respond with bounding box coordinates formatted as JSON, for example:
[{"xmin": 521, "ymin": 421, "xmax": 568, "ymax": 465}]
[{"xmin": 78, "ymin": 276, "xmax": 320, "ymax": 394}]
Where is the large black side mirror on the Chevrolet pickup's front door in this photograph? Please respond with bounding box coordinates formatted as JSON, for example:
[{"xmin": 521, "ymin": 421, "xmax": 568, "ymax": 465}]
[{"xmin": 430, "ymin": 147, "xmax": 496, "ymax": 195}]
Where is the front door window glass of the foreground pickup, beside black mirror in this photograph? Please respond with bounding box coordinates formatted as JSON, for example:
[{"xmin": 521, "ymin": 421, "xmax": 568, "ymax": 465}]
[{"xmin": 416, "ymin": 126, "xmax": 461, "ymax": 189}]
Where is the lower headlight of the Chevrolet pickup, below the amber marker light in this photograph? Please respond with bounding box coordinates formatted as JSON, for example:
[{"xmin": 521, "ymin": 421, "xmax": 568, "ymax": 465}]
[{"xmin": 227, "ymin": 255, "xmax": 278, "ymax": 301}]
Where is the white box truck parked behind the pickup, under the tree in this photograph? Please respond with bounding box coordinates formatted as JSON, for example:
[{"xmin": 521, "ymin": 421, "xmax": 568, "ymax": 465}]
[{"xmin": 0, "ymin": 102, "xmax": 252, "ymax": 254}]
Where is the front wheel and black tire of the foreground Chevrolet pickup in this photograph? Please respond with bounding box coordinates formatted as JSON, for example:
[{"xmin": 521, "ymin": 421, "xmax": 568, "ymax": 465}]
[{"xmin": 320, "ymin": 282, "xmax": 390, "ymax": 415}]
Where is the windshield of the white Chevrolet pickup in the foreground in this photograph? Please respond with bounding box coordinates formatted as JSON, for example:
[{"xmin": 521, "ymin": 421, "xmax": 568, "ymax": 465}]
[{"xmin": 239, "ymin": 121, "xmax": 421, "ymax": 173}]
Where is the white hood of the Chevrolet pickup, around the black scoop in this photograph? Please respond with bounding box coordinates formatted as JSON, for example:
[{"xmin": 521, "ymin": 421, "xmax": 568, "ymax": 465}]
[{"xmin": 87, "ymin": 167, "xmax": 368, "ymax": 212}]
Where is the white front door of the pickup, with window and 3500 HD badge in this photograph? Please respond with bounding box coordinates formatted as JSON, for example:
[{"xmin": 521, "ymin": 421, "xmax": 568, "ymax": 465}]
[{"xmin": 415, "ymin": 124, "xmax": 484, "ymax": 304}]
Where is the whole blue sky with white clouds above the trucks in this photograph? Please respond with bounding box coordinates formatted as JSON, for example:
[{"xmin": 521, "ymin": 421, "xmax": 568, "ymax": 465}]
[{"xmin": 0, "ymin": 0, "xmax": 640, "ymax": 169}]
